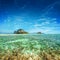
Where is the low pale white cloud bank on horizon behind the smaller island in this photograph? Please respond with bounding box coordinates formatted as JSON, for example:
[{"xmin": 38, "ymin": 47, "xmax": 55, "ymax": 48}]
[{"xmin": 30, "ymin": 27, "xmax": 59, "ymax": 34}]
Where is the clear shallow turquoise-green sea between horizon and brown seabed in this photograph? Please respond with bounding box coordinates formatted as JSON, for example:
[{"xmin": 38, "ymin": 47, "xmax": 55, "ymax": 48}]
[{"xmin": 0, "ymin": 34, "xmax": 60, "ymax": 53}]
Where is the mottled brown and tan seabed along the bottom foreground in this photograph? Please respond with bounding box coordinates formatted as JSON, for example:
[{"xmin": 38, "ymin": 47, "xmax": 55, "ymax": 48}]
[{"xmin": 0, "ymin": 50, "xmax": 60, "ymax": 60}]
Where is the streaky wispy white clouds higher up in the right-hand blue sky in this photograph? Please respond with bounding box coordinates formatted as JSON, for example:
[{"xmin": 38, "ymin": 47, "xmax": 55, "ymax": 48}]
[{"xmin": 34, "ymin": 17, "xmax": 59, "ymax": 27}]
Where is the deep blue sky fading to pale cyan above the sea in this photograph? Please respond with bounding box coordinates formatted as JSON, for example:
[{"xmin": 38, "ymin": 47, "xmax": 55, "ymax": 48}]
[{"xmin": 0, "ymin": 0, "xmax": 60, "ymax": 34}]
